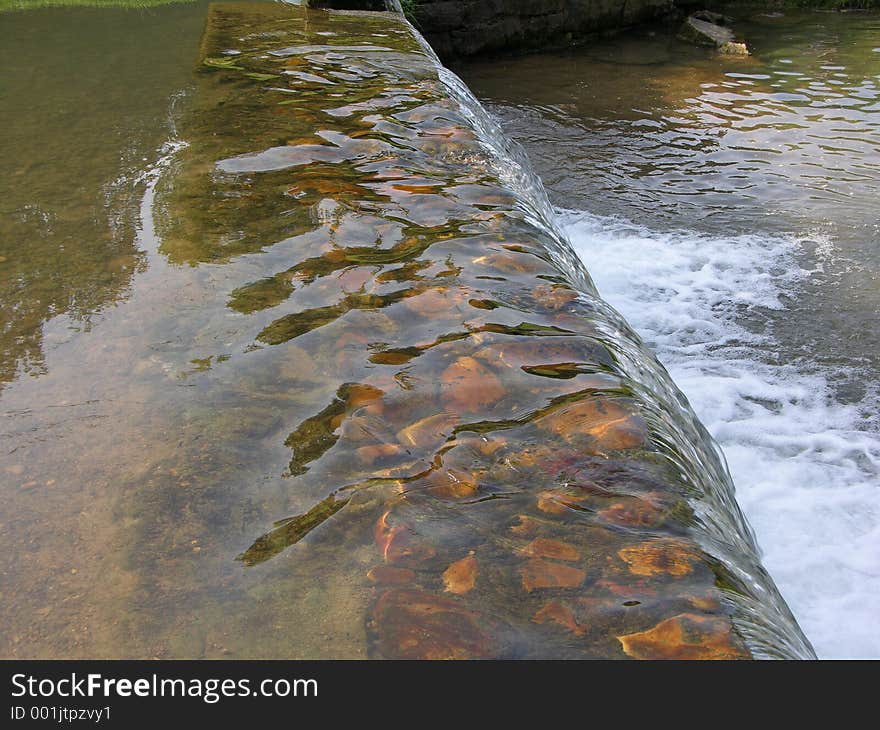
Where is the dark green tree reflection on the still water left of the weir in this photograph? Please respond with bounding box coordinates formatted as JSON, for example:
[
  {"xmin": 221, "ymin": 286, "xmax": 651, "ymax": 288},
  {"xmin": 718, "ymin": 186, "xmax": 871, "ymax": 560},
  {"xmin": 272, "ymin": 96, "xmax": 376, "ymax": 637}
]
[{"xmin": 0, "ymin": 7, "xmax": 210, "ymax": 388}]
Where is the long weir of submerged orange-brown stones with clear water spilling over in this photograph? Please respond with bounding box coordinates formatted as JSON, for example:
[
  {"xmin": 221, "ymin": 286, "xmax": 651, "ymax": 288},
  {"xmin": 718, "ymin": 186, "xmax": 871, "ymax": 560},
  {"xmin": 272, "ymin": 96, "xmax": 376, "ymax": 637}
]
[{"xmin": 157, "ymin": 4, "xmax": 812, "ymax": 659}]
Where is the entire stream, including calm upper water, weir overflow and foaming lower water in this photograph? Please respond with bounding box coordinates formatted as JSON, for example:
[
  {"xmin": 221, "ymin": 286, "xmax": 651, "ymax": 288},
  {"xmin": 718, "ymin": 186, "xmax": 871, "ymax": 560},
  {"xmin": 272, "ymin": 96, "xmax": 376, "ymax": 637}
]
[{"xmin": 0, "ymin": 1, "xmax": 880, "ymax": 658}]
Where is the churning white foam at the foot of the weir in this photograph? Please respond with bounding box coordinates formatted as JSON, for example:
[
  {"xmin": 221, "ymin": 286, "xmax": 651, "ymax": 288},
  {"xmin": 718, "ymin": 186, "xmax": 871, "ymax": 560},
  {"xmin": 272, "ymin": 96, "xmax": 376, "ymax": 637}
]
[{"xmin": 560, "ymin": 211, "xmax": 880, "ymax": 658}]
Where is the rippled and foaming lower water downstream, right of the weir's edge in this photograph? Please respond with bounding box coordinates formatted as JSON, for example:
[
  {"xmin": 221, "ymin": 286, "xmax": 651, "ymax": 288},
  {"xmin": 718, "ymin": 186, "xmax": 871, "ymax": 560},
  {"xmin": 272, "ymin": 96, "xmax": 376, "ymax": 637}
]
[{"xmin": 458, "ymin": 7, "xmax": 880, "ymax": 657}]
